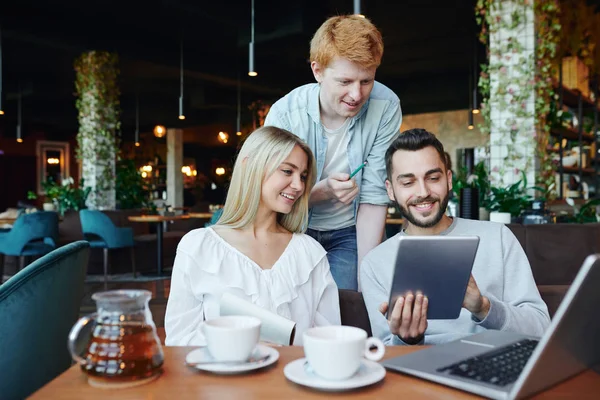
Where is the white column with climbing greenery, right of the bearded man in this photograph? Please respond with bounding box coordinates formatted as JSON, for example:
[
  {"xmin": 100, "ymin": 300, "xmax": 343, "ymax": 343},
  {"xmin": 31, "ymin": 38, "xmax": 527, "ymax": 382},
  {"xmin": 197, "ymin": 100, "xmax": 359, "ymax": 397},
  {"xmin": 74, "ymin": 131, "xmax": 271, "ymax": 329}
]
[{"xmin": 489, "ymin": 0, "xmax": 536, "ymax": 187}]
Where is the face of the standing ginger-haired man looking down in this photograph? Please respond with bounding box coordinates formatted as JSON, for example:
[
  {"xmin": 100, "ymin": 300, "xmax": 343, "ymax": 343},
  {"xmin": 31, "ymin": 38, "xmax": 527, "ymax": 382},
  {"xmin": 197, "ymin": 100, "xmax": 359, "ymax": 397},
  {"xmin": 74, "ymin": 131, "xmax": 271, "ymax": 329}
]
[{"xmin": 311, "ymin": 57, "xmax": 376, "ymax": 129}]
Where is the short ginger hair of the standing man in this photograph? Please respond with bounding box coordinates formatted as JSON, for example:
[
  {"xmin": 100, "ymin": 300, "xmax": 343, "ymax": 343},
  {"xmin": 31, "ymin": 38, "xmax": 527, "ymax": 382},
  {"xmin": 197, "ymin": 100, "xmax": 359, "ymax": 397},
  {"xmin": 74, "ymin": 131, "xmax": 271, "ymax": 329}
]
[{"xmin": 310, "ymin": 15, "xmax": 383, "ymax": 69}]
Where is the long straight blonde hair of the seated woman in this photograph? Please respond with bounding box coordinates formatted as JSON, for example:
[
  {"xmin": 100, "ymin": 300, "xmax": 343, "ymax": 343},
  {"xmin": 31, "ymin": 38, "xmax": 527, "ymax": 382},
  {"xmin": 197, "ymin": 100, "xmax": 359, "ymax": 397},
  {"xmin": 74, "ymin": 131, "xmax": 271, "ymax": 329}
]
[{"xmin": 217, "ymin": 126, "xmax": 316, "ymax": 233}]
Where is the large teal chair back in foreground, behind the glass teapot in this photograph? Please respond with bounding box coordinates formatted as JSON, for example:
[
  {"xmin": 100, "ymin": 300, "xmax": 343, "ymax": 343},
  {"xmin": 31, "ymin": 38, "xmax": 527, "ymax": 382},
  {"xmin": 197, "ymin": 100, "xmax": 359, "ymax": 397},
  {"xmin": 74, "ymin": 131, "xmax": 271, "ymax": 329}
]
[{"xmin": 0, "ymin": 240, "xmax": 90, "ymax": 399}]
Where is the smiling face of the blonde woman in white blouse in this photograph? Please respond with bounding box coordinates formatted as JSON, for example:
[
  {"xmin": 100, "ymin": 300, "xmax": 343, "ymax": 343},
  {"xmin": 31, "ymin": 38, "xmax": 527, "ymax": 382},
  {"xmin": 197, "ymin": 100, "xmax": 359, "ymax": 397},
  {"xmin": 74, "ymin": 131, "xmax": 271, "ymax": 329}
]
[{"xmin": 260, "ymin": 146, "xmax": 308, "ymax": 214}]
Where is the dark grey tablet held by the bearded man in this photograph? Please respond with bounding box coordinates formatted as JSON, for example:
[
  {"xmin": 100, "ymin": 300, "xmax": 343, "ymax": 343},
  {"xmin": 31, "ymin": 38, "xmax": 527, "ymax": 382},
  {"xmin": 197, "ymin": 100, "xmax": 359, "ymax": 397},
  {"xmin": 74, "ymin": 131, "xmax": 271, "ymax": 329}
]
[{"xmin": 388, "ymin": 236, "xmax": 479, "ymax": 319}]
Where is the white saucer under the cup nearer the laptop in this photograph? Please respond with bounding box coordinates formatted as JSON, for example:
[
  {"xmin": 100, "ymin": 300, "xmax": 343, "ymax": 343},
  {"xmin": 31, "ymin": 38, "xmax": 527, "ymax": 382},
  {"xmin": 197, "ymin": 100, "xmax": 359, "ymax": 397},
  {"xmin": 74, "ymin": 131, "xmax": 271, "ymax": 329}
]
[{"xmin": 283, "ymin": 358, "xmax": 385, "ymax": 391}]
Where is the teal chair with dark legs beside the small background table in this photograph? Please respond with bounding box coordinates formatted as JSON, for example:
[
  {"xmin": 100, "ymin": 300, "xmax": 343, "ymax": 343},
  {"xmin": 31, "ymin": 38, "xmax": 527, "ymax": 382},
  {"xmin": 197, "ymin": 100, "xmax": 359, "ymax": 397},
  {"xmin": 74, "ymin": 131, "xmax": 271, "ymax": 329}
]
[{"xmin": 79, "ymin": 210, "xmax": 135, "ymax": 288}]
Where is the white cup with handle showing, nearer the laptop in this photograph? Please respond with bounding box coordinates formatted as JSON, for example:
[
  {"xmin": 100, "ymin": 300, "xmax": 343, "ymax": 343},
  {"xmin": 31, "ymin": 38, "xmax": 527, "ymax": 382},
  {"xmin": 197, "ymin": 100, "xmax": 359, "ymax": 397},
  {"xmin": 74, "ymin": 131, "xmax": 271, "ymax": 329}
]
[{"xmin": 302, "ymin": 326, "xmax": 385, "ymax": 380}]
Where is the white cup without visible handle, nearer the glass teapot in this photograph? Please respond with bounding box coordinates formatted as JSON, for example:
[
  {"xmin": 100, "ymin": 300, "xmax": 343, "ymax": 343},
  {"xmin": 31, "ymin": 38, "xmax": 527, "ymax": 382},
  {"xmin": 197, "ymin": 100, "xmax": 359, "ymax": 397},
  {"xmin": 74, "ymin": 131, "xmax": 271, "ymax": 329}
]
[{"xmin": 202, "ymin": 315, "xmax": 260, "ymax": 361}]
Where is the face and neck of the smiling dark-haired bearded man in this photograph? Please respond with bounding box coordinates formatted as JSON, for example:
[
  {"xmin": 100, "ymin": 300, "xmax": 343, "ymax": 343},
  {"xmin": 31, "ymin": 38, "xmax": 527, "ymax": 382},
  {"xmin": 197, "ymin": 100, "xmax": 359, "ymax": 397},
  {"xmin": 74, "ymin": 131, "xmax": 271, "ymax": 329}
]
[{"xmin": 385, "ymin": 146, "xmax": 452, "ymax": 234}]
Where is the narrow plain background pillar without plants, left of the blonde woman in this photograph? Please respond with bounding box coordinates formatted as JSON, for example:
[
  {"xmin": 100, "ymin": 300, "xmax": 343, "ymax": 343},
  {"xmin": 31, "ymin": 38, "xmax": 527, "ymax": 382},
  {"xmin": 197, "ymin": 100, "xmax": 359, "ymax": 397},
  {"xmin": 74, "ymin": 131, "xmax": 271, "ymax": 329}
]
[{"xmin": 167, "ymin": 128, "xmax": 183, "ymax": 207}]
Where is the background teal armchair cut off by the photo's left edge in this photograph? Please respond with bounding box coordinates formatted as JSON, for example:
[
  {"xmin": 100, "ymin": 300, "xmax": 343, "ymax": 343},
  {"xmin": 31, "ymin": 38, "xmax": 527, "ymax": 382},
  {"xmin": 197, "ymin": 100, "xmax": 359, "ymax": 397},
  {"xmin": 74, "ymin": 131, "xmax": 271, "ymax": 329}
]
[{"xmin": 0, "ymin": 211, "xmax": 58, "ymax": 281}]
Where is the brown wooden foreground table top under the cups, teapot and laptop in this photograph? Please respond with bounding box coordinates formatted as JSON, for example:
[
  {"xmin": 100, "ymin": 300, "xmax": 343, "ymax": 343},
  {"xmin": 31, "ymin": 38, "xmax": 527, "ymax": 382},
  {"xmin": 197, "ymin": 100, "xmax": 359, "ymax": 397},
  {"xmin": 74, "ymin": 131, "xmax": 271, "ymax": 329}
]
[{"xmin": 32, "ymin": 346, "xmax": 600, "ymax": 400}]
